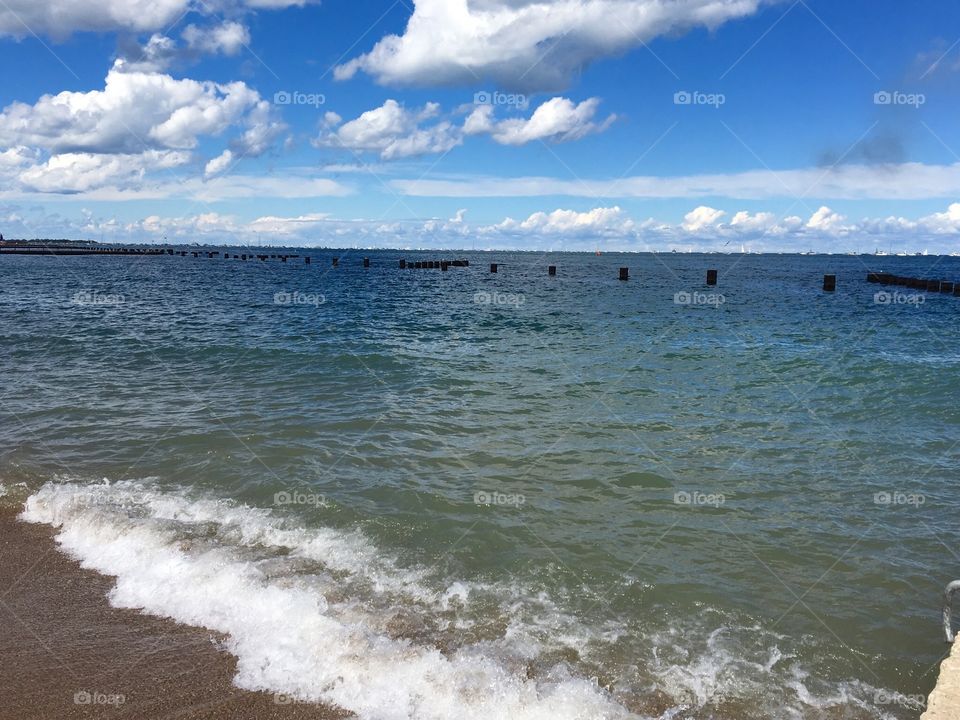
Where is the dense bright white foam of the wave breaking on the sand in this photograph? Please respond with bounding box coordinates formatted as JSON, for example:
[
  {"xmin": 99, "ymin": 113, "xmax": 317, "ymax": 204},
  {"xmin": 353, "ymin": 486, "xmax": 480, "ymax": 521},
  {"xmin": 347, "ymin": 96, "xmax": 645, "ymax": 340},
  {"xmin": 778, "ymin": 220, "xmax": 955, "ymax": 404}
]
[{"xmin": 22, "ymin": 483, "xmax": 630, "ymax": 720}]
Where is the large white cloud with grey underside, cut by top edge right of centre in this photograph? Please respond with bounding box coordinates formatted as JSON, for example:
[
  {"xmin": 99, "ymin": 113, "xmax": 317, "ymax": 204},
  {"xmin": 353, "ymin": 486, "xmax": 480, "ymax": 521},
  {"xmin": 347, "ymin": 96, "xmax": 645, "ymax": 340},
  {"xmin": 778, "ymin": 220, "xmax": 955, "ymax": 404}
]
[{"xmin": 335, "ymin": 0, "xmax": 762, "ymax": 90}]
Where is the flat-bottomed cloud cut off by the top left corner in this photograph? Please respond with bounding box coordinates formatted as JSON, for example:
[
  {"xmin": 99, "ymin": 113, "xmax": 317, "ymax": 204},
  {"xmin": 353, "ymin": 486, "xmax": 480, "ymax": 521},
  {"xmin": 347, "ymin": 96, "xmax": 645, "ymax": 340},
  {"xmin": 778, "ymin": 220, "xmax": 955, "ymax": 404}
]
[{"xmin": 0, "ymin": 0, "xmax": 309, "ymax": 40}]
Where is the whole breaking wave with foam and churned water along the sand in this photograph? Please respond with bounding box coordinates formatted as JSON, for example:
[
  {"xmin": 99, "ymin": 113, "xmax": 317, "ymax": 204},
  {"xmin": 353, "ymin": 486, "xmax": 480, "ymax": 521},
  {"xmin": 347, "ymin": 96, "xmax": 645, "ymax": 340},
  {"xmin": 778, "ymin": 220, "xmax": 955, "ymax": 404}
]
[{"xmin": 21, "ymin": 479, "xmax": 908, "ymax": 720}]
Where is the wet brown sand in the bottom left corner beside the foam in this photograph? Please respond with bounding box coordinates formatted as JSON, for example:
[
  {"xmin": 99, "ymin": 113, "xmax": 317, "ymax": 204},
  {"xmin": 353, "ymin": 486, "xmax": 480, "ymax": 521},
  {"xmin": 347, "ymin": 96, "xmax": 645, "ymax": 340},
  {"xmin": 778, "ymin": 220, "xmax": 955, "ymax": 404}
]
[{"xmin": 0, "ymin": 508, "xmax": 349, "ymax": 720}]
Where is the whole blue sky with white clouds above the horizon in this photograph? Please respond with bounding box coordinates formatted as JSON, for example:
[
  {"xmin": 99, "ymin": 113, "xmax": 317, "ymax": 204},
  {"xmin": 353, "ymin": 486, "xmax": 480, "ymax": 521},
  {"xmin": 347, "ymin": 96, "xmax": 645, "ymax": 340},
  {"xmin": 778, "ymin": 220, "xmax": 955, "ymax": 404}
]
[{"xmin": 0, "ymin": 0, "xmax": 960, "ymax": 253}]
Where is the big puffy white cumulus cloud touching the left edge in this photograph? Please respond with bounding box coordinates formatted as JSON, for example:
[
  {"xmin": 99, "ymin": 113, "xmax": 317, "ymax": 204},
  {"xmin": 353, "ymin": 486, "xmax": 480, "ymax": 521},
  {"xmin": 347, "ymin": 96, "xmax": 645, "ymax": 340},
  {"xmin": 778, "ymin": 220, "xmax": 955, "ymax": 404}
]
[{"xmin": 0, "ymin": 67, "xmax": 286, "ymax": 193}]
